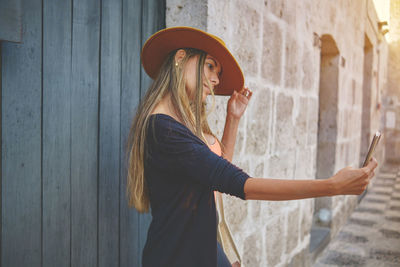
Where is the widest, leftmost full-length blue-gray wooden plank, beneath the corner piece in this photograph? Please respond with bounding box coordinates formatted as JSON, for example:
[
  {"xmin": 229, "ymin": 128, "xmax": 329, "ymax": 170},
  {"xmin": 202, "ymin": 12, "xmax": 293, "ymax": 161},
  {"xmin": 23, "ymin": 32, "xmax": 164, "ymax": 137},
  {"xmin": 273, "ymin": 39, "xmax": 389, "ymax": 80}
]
[{"xmin": 1, "ymin": 0, "xmax": 42, "ymax": 266}]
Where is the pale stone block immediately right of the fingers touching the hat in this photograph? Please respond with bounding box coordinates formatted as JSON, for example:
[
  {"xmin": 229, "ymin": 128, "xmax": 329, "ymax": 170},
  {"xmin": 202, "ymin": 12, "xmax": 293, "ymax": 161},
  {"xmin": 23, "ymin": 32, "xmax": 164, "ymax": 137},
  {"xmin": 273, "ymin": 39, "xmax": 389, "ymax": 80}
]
[{"xmin": 245, "ymin": 89, "xmax": 271, "ymax": 155}]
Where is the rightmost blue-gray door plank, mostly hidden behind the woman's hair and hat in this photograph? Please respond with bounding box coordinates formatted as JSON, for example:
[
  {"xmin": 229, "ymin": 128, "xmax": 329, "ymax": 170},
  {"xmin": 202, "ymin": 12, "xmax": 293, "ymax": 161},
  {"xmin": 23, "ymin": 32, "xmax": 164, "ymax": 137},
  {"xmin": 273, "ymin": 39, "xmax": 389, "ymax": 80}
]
[{"xmin": 139, "ymin": 0, "xmax": 165, "ymax": 266}]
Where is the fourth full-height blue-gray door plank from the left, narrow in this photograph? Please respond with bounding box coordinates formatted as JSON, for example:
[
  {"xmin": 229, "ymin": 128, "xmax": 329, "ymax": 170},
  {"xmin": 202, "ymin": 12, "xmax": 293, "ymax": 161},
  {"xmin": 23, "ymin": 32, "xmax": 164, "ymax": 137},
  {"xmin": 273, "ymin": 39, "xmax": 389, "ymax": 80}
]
[{"xmin": 99, "ymin": 0, "xmax": 122, "ymax": 267}]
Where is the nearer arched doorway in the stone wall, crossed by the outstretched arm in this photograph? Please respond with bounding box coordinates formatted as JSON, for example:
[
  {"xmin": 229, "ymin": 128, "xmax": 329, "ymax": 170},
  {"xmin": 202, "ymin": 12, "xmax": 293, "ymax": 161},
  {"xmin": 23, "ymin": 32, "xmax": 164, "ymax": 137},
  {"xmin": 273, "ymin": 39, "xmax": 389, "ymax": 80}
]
[{"xmin": 310, "ymin": 35, "xmax": 340, "ymax": 259}]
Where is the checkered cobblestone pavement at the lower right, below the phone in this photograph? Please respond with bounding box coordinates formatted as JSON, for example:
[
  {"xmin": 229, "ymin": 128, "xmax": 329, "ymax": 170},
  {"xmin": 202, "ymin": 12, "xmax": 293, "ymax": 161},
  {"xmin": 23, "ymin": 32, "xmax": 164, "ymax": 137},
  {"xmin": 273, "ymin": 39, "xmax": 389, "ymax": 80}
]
[{"xmin": 314, "ymin": 164, "xmax": 400, "ymax": 267}]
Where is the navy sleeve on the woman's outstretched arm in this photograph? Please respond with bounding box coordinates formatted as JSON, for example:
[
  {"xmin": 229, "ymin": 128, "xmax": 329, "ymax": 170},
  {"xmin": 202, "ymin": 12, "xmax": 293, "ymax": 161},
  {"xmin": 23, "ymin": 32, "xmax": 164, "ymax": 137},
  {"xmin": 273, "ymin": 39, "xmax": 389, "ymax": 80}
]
[{"xmin": 145, "ymin": 115, "xmax": 249, "ymax": 199}]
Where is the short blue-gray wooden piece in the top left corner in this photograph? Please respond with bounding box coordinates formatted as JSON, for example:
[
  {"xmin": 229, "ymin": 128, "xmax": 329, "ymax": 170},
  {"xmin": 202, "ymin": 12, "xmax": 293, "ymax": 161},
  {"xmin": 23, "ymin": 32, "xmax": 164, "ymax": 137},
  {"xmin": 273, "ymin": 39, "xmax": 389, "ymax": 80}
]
[{"xmin": 0, "ymin": 0, "xmax": 22, "ymax": 42}]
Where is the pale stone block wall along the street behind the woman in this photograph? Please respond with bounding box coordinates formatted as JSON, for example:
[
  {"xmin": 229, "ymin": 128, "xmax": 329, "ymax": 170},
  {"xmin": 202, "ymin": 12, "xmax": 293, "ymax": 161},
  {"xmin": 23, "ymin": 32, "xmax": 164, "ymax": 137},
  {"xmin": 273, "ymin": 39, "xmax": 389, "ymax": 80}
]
[{"xmin": 167, "ymin": 0, "xmax": 387, "ymax": 266}]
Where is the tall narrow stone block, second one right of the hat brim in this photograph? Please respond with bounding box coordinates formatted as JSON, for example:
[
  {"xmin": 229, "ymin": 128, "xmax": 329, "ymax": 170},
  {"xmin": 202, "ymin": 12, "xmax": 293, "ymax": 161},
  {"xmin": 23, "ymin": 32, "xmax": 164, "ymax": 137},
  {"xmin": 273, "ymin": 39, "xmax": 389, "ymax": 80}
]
[{"xmin": 261, "ymin": 15, "xmax": 283, "ymax": 85}]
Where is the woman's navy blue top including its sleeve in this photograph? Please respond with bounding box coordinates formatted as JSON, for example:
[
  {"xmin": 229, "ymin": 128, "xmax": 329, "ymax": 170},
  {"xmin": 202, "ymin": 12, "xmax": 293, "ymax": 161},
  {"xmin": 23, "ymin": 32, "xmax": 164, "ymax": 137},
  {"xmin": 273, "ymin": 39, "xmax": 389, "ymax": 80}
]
[{"xmin": 142, "ymin": 114, "xmax": 249, "ymax": 267}]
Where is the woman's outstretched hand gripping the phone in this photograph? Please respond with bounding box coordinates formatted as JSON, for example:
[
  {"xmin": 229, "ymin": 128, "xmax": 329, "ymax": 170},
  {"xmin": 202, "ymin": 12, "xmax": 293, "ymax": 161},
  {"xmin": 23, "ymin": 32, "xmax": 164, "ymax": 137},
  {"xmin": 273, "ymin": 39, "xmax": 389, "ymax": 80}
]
[{"xmin": 330, "ymin": 158, "xmax": 378, "ymax": 195}]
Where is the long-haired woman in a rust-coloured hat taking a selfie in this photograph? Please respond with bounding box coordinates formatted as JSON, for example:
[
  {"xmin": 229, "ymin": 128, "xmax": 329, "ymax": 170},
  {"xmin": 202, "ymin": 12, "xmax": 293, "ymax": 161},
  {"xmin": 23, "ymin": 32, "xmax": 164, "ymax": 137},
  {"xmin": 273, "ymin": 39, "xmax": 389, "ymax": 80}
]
[{"xmin": 127, "ymin": 27, "xmax": 377, "ymax": 266}]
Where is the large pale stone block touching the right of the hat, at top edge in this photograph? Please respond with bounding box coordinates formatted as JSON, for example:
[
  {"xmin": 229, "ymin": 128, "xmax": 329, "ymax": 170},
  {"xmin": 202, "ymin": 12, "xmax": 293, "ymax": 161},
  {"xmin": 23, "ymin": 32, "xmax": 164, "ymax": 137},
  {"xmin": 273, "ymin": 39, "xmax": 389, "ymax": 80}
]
[{"xmin": 231, "ymin": 1, "xmax": 262, "ymax": 76}]
